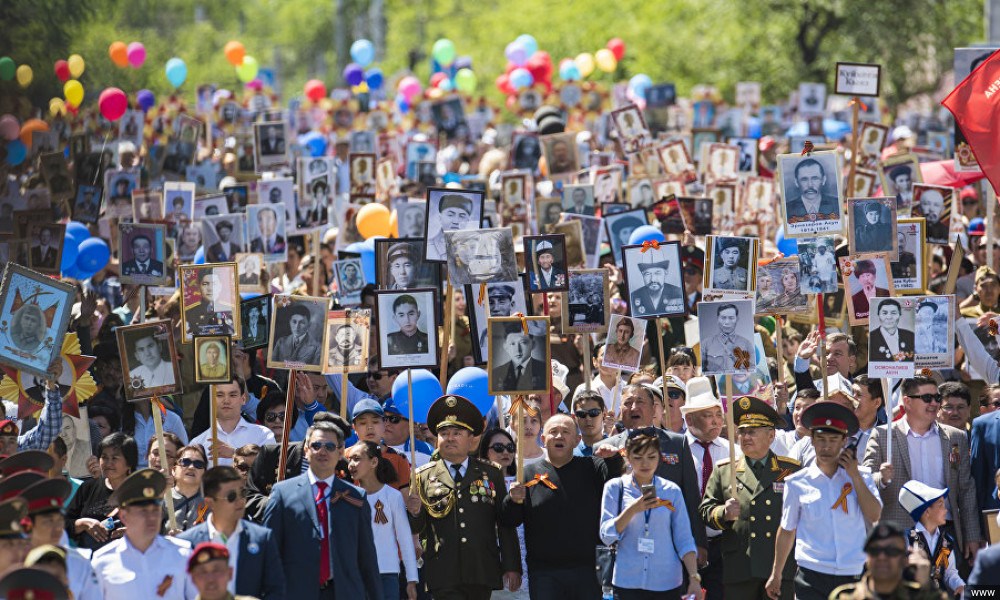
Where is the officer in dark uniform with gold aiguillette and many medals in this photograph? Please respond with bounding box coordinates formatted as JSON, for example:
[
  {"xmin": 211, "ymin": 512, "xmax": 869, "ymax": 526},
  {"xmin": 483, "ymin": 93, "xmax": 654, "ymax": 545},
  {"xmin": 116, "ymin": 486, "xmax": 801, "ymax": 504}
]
[{"xmin": 408, "ymin": 396, "xmax": 521, "ymax": 600}]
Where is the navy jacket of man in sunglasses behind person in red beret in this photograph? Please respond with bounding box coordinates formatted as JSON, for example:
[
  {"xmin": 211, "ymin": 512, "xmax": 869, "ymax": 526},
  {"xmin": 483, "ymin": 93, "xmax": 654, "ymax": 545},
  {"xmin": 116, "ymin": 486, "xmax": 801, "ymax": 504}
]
[{"xmin": 177, "ymin": 521, "xmax": 285, "ymax": 600}]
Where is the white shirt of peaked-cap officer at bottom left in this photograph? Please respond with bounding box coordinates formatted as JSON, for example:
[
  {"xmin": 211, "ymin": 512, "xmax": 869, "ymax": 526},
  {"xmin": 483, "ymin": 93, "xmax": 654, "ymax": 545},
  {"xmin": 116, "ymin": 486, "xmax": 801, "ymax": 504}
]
[{"xmin": 92, "ymin": 535, "xmax": 198, "ymax": 600}]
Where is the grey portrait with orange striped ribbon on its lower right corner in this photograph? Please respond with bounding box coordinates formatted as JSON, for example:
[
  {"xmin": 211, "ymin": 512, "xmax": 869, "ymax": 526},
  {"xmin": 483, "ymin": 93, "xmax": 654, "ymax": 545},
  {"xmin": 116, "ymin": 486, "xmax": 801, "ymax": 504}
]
[{"xmin": 698, "ymin": 300, "xmax": 757, "ymax": 375}]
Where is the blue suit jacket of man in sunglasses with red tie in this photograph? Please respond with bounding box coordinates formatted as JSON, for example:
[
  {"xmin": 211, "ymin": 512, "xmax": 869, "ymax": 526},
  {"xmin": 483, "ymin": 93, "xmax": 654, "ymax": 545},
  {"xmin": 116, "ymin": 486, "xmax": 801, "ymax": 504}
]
[{"xmin": 264, "ymin": 474, "xmax": 383, "ymax": 600}]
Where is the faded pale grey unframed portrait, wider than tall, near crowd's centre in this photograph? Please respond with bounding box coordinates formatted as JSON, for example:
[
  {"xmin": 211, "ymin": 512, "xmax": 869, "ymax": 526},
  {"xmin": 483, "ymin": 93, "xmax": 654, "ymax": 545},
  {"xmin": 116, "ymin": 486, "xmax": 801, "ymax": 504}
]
[{"xmin": 445, "ymin": 227, "xmax": 517, "ymax": 285}]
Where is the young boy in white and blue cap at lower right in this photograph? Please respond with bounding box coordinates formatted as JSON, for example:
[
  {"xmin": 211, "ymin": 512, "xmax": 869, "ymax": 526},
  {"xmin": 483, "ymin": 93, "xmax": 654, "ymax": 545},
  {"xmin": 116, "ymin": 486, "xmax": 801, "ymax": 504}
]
[{"xmin": 899, "ymin": 479, "xmax": 965, "ymax": 598}]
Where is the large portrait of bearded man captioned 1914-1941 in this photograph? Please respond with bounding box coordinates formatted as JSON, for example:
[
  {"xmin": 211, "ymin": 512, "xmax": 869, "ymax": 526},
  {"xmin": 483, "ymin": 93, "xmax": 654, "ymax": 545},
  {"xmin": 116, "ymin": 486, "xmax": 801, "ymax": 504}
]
[{"xmin": 776, "ymin": 151, "xmax": 844, "ymax": 238}]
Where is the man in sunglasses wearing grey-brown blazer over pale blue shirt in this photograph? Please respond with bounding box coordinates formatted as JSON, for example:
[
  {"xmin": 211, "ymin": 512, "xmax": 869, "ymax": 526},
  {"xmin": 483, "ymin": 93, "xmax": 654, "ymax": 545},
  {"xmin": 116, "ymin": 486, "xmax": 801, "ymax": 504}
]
[{"xmin": 864, "ymin": 375, "xmax": 983, "ymax": 572}]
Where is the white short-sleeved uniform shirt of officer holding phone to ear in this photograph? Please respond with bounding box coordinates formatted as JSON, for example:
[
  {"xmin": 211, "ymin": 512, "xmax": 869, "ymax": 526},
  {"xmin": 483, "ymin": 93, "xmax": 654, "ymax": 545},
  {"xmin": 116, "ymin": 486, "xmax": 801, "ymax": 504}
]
[{"xmin": 781, "ymin": 465, "xmax": 882, "ymax": 575}]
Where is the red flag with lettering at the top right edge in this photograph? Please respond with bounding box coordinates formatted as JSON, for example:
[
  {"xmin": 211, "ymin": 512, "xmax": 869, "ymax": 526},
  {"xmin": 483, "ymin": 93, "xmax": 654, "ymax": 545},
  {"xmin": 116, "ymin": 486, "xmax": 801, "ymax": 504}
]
[{"xmin": 941, "ymin": 52, "xmax": 1000, "ymax": 190}]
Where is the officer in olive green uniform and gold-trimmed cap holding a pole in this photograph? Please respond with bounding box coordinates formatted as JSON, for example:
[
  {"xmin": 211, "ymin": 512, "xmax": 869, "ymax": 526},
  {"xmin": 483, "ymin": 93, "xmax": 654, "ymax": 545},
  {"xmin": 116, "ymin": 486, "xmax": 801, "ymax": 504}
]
[{"xmin": 698, "ymin": 396, "xmax": 801, "ymax": 600}]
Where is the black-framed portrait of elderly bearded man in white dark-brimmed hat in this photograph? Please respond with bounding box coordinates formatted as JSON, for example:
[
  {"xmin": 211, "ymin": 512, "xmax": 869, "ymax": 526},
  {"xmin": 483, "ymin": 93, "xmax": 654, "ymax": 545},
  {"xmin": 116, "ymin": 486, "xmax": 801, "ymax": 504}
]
[{"xmin": 622, "ymin": 242, "xmax": 686, "ymax": 319}]
